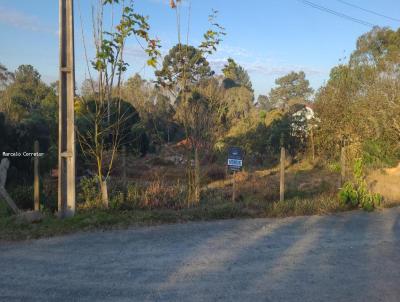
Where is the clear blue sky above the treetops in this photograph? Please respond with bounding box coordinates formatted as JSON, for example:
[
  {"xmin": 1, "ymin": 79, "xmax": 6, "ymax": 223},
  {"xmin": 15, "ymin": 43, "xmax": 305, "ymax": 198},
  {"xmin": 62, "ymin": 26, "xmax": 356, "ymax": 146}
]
[{"xmin": 0, "ymin": 0, "xmax": 400, "ymax": 95}]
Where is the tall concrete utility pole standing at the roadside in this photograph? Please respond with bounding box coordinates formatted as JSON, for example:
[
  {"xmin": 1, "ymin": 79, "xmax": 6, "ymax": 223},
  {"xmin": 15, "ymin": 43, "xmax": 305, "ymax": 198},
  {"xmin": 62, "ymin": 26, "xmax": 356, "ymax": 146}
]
[{"xmin": 58, "ymin": 0, "xmax": 75, "ymax": 218}]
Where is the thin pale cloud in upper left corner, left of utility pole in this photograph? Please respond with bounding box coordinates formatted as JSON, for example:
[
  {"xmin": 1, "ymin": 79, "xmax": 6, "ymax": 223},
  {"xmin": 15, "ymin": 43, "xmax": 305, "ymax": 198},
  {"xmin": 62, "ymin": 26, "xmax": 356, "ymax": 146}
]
[{"xmin": 0, "ymin": 6, "xmax": 58, "ymax": 35}]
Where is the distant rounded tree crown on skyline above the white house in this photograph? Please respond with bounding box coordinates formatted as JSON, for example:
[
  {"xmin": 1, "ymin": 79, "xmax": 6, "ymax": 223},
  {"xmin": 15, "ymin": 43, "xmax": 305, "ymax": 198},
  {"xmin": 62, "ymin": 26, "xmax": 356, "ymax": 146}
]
[{"xmin": 269, "ymin": 71, "xmax": 313, "ymax": 108}]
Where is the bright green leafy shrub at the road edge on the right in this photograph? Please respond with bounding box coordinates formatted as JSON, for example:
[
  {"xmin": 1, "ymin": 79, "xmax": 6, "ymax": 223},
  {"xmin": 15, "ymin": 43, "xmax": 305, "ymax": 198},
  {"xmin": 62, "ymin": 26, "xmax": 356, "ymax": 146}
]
[{"xmin": 339, "ymin": 159, "xmax": 383, "ymax": 211}]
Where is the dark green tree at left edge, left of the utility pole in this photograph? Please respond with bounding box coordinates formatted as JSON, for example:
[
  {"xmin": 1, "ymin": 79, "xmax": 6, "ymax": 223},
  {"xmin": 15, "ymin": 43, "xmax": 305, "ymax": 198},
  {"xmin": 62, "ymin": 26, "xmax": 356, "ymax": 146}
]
[{"xmin": 0, "ymin": 65, "xmax": 58, "ymax": 184}]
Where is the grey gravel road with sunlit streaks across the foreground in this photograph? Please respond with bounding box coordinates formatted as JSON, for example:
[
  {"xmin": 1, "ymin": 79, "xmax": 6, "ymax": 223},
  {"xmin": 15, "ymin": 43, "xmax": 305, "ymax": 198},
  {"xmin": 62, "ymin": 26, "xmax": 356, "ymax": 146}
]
[{"xmin": 0, "ymin": 208, "xmax": 400, "ymax": 302}]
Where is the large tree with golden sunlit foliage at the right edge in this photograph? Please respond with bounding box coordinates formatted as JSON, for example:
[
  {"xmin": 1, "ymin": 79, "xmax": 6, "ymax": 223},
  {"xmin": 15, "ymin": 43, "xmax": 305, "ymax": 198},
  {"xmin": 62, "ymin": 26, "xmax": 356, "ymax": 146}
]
[{"xmin": 315, "ymin": 27, "xmax": 400, "ymax": 163}]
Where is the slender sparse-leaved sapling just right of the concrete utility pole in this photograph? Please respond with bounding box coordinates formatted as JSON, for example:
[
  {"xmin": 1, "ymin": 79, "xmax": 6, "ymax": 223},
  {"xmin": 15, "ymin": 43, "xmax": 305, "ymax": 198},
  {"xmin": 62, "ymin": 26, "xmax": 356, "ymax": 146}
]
[{"xmin": 78, "ymin": 0, "xmax": 160, "ymax": 207}]
